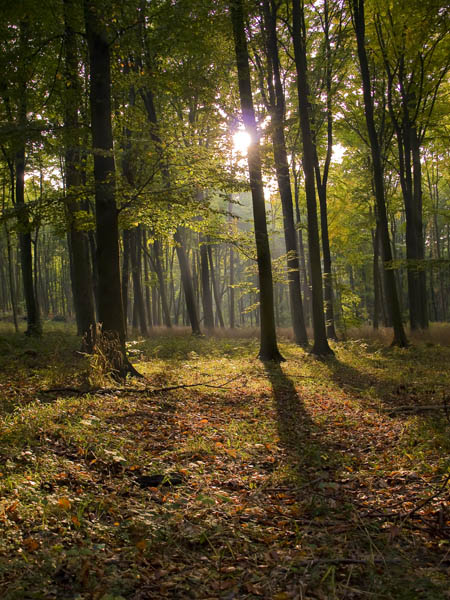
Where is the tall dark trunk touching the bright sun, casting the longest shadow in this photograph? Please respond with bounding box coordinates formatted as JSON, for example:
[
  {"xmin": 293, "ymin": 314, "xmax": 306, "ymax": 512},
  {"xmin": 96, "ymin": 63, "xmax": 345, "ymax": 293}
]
[{"xmin": 231, "ymin": 0, "xmax": 283, "ymax": 362}]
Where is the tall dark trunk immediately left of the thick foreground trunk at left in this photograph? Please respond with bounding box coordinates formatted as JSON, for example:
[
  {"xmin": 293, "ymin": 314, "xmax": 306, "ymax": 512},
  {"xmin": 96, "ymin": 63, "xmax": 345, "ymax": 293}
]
[{"xmin": 64, "ymin": 0, "xmax": 95, "ymax": 351}]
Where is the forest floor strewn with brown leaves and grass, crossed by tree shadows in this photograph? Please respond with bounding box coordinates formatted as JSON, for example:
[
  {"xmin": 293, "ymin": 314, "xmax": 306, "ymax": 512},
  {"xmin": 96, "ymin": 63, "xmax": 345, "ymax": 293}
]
[{"xmin": 0, "ymin": 326, "xmax": 450, "ymax": 600}]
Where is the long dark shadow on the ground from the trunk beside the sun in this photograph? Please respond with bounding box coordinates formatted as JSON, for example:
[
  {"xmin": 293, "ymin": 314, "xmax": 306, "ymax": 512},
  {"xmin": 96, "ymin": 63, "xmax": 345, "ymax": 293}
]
[{"xmin": 265, "ymin": 363, "xmax": 342, "ymax": 483}]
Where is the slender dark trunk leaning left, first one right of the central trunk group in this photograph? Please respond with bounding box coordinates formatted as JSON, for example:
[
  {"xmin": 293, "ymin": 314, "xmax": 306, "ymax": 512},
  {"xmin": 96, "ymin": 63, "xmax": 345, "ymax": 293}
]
[{"xmin": 350, "ymin": 0, "xmax": 408, "ymax": 347}]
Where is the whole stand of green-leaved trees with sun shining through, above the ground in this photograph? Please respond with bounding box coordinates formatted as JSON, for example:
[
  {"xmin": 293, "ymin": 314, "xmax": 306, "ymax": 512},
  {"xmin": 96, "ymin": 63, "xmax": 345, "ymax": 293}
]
[{"xmin": 0, "ymin": 0, "xmax": 450, "ymax": 356}]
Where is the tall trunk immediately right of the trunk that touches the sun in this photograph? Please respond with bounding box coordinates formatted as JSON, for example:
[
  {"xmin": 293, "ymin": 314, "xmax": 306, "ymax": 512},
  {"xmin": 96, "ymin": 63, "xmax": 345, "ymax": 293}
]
[{"xmin": 264, "ymin": 0, "xmax": 308, "ymax": 346}]
